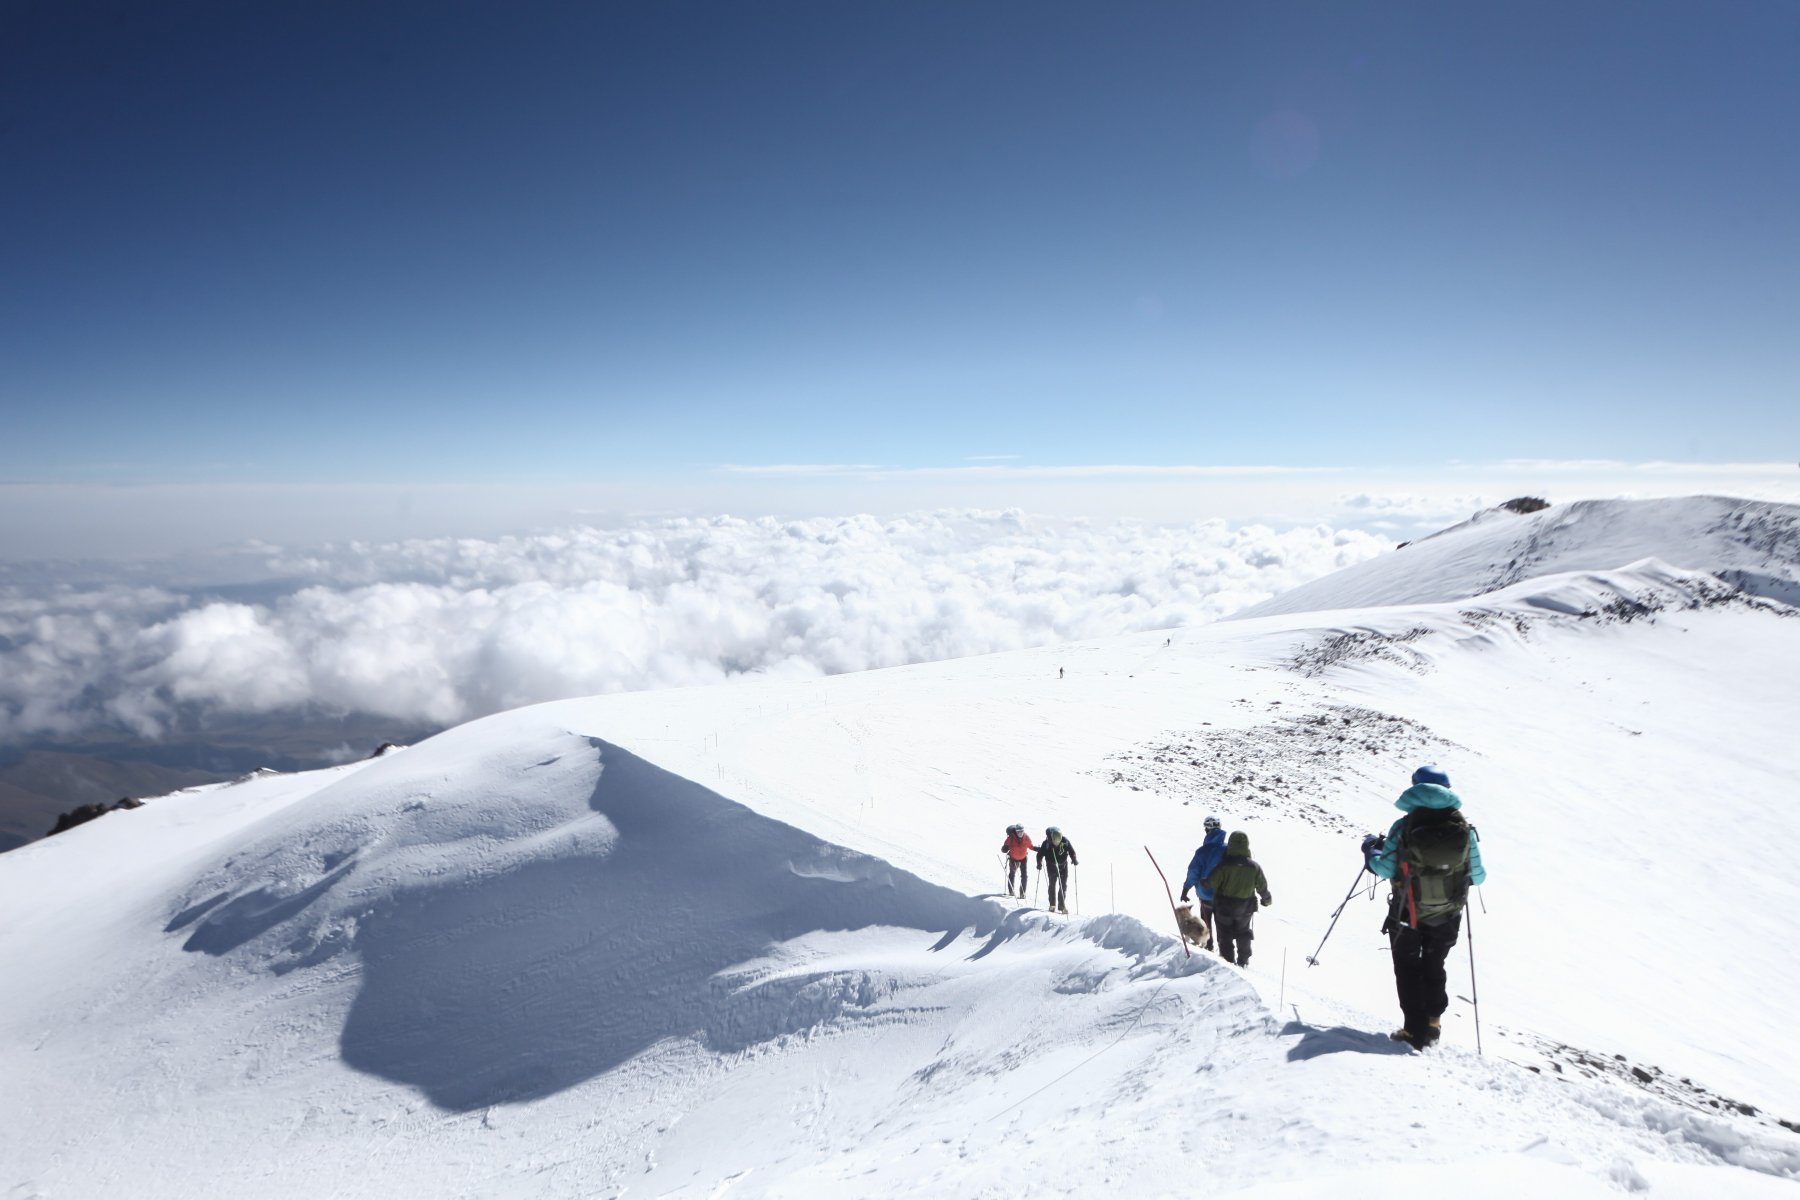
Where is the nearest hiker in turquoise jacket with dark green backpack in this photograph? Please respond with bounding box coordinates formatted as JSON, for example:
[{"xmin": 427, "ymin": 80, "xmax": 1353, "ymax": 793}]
[{"xmin": 1363, "ymin": 763, "xmax": 1487, "ymax": 1049}]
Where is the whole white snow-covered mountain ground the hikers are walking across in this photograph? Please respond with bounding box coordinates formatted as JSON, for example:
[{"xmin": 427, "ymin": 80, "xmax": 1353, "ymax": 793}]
[{"xmin": 0, "ymin": 498, "xmax": 1800, "ymax": 1200}]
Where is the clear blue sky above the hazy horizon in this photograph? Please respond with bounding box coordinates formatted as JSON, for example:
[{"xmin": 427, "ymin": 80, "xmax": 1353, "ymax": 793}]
[{"xmin": 0, "ymin": 0, "xmax": 1800, "ymax": 482}]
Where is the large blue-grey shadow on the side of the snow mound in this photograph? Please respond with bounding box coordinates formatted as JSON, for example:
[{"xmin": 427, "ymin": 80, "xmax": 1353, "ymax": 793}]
[{"xmin": 180, "ymin": 741, "xmax": 1024, "ymax": 1112}]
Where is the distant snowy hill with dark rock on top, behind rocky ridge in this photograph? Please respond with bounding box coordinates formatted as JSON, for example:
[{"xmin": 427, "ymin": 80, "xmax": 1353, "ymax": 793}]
[{"xmin": 1233, "ymin": 497, "xmax": 1800, "ymax": 621}]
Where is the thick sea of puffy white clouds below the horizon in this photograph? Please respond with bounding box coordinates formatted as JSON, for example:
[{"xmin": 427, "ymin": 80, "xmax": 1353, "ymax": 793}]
[{"xmin": 0, "ymin": 511, "xmax": 1393, "ymax": 745}]
